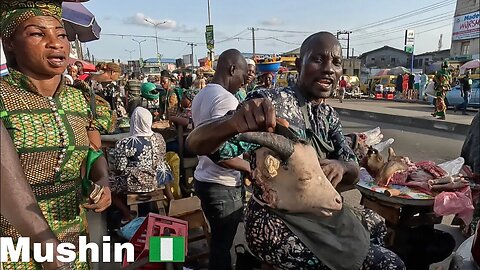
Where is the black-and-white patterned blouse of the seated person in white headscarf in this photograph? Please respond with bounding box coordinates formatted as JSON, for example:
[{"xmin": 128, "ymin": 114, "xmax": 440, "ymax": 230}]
[{"xmin": 114, "ymin": 133, "xmax": 171, "ymax": 192}]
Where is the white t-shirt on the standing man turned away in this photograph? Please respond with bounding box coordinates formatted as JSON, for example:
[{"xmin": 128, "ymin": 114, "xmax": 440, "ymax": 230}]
[{"xmin": 192, "ymin": 83, "xmax": 241, "ymax": 186}]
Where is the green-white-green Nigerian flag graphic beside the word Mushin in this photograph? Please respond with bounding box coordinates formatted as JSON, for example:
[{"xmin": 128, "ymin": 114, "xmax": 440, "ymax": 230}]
[{"xmin": 149, "ymin": 236, "xmax": 185, "ymax": 262}]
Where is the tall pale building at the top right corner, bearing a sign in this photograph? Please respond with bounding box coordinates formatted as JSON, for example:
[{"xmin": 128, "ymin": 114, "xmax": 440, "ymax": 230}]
[{"xmin": 450, "ymin": 0, "xmax": 480, "ymax": 61}]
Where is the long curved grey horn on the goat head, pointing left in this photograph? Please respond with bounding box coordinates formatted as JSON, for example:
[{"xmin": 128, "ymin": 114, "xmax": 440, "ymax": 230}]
[{"xmin": 237, "ymin": 132, "xmax": 294, "ymax": 161}]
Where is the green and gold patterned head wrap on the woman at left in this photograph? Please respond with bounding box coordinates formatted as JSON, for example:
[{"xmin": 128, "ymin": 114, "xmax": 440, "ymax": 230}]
[{"xmin": 0, "ymin": 0, "xmax": 62, "ymax": 38}]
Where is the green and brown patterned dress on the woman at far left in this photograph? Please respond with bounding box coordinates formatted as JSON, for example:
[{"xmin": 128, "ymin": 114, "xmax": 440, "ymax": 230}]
[{"xmin": 0, "ymin": 69, "xmax": 111, "ymax": 269}]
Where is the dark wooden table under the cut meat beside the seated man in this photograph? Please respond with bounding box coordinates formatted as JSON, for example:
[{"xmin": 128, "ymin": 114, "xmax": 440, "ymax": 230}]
[{"xmin": 357, "ymin": 171, "xmax": 455, "ymax": 269}]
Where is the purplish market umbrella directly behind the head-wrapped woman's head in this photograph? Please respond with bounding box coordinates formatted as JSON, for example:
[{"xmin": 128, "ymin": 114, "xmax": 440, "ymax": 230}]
[{"xmin": 62, "ymin": 2, "xmax": 102, "ymax": 42}]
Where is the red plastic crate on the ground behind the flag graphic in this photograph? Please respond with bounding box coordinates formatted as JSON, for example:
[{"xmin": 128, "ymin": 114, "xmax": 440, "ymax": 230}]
[{"xmin": 122, "ymin": 213, "xmax": 188, "ymax": 270}]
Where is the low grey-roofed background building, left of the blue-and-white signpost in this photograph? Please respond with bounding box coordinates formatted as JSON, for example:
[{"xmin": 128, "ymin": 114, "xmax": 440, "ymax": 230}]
[{"xmin": 358, "ymin": 46, "xmax": 411, "ymax": 68}]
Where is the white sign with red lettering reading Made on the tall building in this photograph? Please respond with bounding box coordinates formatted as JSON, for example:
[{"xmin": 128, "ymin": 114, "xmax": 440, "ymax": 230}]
[{"xmin": 452, "ymin": 11, "xmax": 480, "ymax": 40}]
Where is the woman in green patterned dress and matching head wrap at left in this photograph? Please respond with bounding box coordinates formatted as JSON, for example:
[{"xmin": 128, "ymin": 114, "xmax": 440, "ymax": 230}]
[{"xmin": 0, "ymin": 0, "xmax": 112, "ymax": 269}]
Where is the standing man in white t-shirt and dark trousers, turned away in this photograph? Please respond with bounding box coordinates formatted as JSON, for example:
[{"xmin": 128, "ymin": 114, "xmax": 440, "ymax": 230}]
[{"xmin": 192, "ymin": 49, "xmax": 250, "ymax": 270}]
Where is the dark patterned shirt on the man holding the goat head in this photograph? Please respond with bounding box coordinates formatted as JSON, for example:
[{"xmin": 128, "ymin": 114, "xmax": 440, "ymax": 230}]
[{"xmin": 219, "ymin": 87, "xmax": 357, "ymax": 161}]
